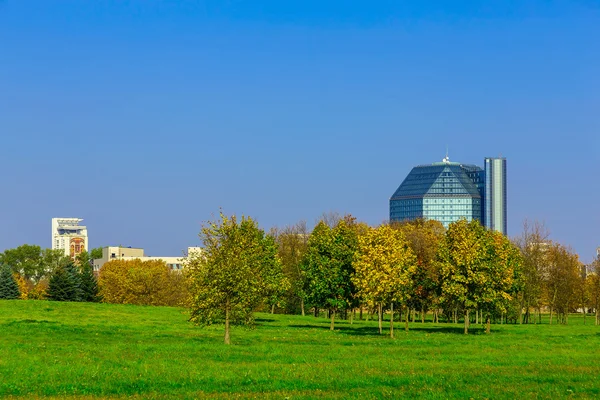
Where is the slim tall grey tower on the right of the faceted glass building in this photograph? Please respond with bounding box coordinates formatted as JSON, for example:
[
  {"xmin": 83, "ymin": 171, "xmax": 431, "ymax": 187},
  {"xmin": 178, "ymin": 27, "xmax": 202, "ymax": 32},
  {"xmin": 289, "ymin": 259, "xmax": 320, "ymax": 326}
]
[{"xmin": 483, "ymin": 157, "xmax": 507, "ymax": 235}]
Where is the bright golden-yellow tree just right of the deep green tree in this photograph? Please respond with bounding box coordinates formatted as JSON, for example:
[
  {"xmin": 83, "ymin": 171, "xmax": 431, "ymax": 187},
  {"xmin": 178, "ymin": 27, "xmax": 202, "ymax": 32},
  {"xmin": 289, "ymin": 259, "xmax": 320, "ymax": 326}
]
[{"xmin": 353, "ymin": 225, "xmax": 417, "ymax": 337}]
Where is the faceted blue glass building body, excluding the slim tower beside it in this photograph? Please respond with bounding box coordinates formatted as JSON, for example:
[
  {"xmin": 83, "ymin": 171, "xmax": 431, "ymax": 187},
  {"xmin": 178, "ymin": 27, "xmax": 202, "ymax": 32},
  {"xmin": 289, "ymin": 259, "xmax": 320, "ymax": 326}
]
[{"xmin": 390, "ymin": 157, "xmax": 485, "ymax": 228}]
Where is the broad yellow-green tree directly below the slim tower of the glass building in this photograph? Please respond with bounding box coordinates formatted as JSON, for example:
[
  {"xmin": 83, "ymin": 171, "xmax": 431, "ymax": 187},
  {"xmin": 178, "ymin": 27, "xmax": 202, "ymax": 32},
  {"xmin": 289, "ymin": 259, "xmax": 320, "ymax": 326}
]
[{"xmin": 438, "ymin": 219, "xmax": 521, "ymax": 334}]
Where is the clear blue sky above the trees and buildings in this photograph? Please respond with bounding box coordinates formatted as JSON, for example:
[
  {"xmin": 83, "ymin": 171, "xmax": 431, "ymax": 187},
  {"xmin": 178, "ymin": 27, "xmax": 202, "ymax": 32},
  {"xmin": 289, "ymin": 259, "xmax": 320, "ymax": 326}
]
[{"xmin": 0, "ymin": 0, "xmax": 600, "ymax": 261}]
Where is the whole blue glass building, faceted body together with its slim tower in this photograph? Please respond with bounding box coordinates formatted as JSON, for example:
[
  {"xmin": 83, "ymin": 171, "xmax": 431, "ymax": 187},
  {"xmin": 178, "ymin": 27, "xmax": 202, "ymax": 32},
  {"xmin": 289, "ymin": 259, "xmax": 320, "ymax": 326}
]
[{"xmin": 390, "ymin": 156, "xmax": 506, "ymax": 234}]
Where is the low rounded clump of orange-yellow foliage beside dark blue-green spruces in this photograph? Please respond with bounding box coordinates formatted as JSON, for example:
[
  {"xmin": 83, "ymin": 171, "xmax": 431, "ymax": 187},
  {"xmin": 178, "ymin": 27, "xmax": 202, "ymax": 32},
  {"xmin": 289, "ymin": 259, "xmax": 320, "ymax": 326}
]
[{"xmin": 98, "ymin": 259, "xmax": 187, "ymax": 306}]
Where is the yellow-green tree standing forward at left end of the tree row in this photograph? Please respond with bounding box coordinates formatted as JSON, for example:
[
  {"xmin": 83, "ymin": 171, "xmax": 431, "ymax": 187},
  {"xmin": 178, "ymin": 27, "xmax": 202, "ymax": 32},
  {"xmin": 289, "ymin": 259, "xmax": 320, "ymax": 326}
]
[{"xmin": 186, "ymin": 212, "xmax": 283, "ymax": 344}]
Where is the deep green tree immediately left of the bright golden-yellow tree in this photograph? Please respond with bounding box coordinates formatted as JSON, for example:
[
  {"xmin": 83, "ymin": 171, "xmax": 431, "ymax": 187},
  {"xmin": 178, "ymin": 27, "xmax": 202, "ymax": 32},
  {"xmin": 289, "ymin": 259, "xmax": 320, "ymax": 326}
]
[{"xmin": 302, "ymin": 216, "xmax": 358, "ymax": 330}]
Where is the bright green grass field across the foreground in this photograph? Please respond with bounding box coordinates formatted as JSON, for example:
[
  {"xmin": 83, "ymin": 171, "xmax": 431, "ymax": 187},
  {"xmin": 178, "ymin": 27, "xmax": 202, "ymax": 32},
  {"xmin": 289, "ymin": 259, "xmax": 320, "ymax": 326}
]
[{"xmin": 0, "ymin": 301, "xmax": 600, "ymax": 399}]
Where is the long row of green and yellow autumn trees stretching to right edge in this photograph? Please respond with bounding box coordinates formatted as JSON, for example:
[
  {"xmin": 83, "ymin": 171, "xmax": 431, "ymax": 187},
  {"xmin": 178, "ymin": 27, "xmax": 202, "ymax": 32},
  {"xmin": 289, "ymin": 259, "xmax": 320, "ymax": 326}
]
[{"xmin": 187, "ymin": 214, "xmax": 600, "ymax": 342}]
